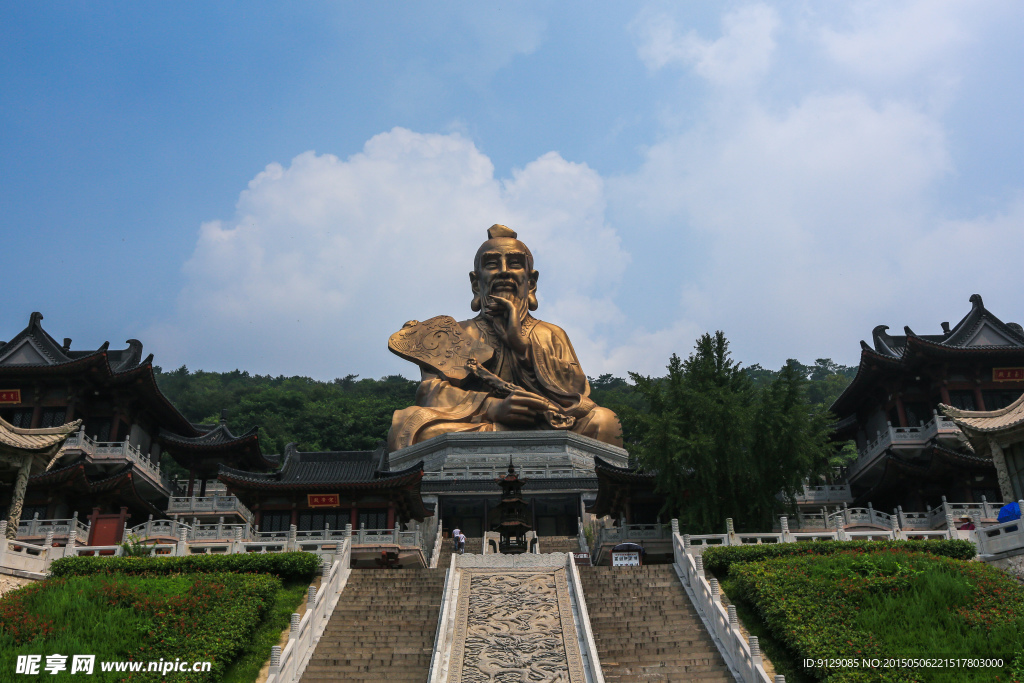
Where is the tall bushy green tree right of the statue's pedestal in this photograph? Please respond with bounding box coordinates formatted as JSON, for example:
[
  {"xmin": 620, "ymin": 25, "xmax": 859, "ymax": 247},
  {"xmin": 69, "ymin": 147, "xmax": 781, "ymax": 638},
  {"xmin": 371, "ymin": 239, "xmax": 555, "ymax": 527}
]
[{"xmin": 631, "ymin": 332, "xmax": 834, "ymax": 532}]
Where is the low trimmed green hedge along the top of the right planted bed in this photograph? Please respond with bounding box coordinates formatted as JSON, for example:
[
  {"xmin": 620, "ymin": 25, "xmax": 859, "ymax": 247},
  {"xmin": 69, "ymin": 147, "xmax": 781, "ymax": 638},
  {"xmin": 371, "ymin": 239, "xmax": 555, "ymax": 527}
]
[{"xmin": 703, "ymin": 541, "xmax": 977, "ymax": 578}]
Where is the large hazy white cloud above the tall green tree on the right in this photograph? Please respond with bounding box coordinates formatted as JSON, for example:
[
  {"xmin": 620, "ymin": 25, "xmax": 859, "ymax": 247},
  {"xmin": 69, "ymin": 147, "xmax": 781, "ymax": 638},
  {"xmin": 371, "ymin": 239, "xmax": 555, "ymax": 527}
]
[{"xmin": 610, "ymin": 93, "xmax": 950, "ymax": 365}]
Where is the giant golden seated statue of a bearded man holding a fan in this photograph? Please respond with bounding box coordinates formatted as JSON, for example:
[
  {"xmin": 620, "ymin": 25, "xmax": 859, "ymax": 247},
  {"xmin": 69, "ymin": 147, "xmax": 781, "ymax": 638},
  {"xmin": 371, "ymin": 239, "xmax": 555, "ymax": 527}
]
[{"xmin": 388, "ymin": 225, "xmax": 623, "ymax": 451}]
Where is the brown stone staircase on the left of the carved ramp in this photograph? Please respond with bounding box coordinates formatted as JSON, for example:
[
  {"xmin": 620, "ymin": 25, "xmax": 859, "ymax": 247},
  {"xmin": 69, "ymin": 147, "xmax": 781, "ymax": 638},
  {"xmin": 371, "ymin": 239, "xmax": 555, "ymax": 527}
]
[{"xmin": 301, "ymin": 565, "xmax": 444, "ymax": 683}]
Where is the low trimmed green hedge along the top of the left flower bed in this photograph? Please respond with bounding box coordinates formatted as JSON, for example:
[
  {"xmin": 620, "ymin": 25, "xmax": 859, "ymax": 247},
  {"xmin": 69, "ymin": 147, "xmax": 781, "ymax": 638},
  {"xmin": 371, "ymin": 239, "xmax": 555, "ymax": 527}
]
[{"xmin": 50, "ymin": 552, "xmax": 321, "ymax": 581}]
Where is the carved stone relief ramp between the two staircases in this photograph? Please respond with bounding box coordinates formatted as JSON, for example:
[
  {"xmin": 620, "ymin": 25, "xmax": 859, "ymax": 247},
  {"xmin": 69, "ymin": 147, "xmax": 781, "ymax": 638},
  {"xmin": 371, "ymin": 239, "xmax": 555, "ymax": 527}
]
[{"xmin": 430, "ymin": 553, "xmax": 603, "ymax": 683}]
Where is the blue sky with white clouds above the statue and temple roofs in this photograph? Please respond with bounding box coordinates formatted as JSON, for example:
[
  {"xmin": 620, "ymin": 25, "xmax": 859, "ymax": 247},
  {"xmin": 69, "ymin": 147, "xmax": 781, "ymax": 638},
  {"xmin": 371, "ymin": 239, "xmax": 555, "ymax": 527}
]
[{"xmin": 0, "ymin": 0, "xmax": 1024, "ymax": 379}]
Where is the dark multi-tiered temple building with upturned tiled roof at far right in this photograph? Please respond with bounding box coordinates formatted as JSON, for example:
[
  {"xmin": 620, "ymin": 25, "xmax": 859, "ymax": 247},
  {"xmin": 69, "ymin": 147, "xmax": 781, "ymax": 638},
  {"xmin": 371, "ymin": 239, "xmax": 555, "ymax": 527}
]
[{"xmin": 831, "ymin": 294, "xmax": 1024, "ymax": 510}]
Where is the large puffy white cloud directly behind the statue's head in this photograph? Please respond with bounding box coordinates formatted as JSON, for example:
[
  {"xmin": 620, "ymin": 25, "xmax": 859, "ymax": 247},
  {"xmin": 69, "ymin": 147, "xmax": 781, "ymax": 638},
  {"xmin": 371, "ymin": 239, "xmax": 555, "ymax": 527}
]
[{"xmin": 146, "ymin": 128, "xmax": 629, "ymax": 378}]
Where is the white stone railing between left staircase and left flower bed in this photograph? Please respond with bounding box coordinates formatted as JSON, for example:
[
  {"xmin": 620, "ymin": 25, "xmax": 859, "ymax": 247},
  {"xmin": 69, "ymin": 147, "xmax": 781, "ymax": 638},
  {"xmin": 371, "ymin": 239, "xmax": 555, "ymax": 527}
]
[{"xmin": 266, "ymin": 539, "xmax": 352, "ymax": 683}]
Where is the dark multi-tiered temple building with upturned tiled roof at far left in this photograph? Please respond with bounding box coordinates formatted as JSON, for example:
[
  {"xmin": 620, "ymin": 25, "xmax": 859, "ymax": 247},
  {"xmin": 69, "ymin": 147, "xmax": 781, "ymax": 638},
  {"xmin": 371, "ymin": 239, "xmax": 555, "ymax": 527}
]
[{"xmin": 0, "ymin": 312, "xmax": 273, "ymax": 542}]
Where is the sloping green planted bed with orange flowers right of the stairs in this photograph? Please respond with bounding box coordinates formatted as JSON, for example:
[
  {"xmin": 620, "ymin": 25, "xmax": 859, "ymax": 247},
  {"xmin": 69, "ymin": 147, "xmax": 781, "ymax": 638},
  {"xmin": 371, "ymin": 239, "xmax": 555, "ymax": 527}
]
[{"xmin": 722, "ymin": 549, "xmax": 1024, "ymax": 683}]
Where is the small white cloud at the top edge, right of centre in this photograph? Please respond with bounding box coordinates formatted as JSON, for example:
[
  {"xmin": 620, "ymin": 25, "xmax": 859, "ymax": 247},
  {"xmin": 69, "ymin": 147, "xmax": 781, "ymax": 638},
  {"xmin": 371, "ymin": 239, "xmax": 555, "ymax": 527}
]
[{"xmin": 633, "ymin": 4, "xmax": 778, "ymax": 85}]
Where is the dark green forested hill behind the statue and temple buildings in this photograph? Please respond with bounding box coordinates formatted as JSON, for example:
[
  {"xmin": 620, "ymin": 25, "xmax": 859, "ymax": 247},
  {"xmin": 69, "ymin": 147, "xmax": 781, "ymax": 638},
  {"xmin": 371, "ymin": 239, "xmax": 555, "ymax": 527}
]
[{"xmin": 155, "ymin": 358, "xmax": 857, "ymax": 453}]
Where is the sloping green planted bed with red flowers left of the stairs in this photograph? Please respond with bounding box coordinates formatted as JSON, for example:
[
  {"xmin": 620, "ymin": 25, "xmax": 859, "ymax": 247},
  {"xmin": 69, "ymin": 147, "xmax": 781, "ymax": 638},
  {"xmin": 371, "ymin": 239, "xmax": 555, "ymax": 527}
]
[{"xmin": 0, "ymin": 572, "xmax": 288, "ymax": 683}]
